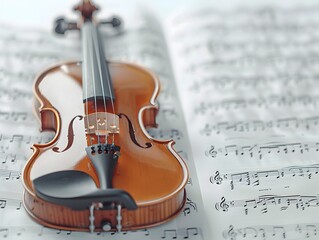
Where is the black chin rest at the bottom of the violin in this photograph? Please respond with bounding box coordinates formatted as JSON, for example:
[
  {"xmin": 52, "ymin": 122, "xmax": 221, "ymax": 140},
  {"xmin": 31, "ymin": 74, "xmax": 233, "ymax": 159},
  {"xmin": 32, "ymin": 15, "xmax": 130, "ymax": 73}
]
[{"xmin": 33, "ymin": 170, "xmax": 137, "ymax": 210}]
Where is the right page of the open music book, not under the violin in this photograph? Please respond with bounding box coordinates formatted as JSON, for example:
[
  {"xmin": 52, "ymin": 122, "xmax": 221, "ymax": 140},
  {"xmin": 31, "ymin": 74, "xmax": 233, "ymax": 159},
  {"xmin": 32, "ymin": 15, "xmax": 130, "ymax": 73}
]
[{"xmin": 168, "ymin": 2, "xmax": 319, "ymax": 240}]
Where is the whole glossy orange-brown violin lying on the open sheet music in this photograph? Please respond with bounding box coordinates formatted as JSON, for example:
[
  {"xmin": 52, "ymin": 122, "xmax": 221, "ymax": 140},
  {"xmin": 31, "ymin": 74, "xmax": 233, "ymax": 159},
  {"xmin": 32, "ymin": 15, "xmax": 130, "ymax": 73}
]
[{"xmin": 22, "ymin": 0, "xmax": 188, "ymax": 232}]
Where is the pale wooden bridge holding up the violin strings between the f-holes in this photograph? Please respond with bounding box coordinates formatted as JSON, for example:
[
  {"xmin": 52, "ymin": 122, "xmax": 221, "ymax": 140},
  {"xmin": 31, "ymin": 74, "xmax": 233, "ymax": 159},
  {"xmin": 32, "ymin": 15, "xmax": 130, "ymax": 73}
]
[{"xmin": 84, "ymin": 112, "xmax": 120, "ymax": 135}]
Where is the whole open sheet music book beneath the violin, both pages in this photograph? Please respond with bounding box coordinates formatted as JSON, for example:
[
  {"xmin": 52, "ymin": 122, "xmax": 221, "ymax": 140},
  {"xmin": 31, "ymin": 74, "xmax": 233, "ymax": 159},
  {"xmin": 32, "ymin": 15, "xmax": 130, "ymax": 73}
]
[{"xmin": 0, "ymin": 1, "xmax": 319, "ymax": 240}]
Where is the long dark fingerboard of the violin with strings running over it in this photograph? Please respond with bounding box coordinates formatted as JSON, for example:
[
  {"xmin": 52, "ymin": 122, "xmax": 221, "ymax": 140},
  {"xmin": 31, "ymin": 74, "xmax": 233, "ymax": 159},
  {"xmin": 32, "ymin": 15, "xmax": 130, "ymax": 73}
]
[{"xmin": 81, "ymin": 20, "xmax": 115, "ymax": 102}]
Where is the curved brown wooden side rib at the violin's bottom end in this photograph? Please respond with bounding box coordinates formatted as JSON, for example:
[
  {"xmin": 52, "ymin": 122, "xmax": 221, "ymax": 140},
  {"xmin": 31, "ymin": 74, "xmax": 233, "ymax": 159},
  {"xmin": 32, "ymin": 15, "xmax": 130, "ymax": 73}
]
[{"xmin": 24, "ymin": 188, "xmax": 186, "ymax": 232}]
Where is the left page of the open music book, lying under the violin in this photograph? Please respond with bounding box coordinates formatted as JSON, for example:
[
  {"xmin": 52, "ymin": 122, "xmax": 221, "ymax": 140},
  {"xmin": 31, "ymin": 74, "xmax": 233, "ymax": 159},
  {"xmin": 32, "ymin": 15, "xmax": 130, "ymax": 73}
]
[{"xmin": 0, "ymin": 8, "xmax": 206, "ymax": 240}]
